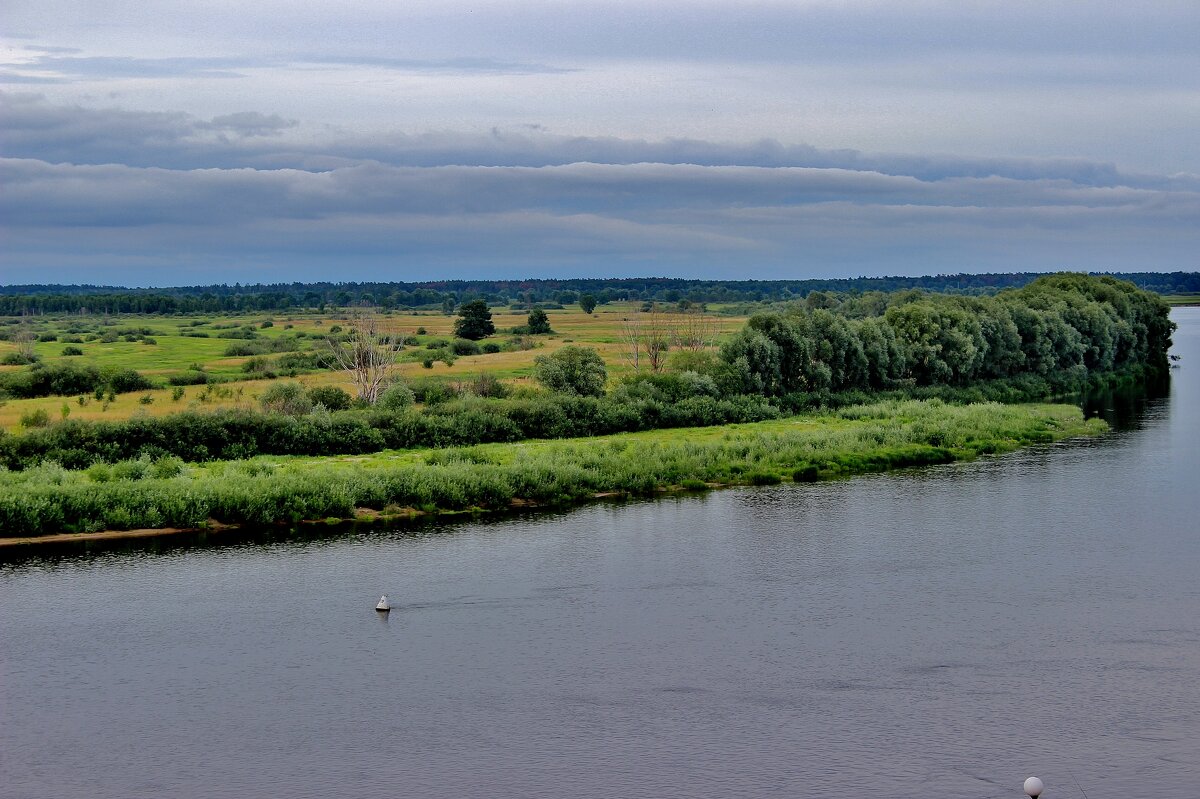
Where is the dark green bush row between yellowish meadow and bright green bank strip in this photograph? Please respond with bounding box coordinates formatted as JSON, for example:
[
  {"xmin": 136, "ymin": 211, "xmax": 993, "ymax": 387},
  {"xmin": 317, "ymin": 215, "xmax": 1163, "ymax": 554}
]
[{"xmin": 0, "ymin": 396, "xmax": 779, "ymax": 469}]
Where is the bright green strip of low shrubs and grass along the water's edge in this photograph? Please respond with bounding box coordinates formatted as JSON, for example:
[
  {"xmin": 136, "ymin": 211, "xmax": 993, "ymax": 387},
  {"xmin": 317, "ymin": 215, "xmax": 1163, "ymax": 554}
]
[{"xmin": 0, "ymin": 400, "xmax": 1105, "ymax": 536}]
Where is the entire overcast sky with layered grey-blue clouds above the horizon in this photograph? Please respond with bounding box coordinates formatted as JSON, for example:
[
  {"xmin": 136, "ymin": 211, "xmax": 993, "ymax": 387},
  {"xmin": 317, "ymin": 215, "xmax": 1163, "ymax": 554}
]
[{"xmin": 0, "ymin": 0, "xmax": 1200, "ymax": 286}]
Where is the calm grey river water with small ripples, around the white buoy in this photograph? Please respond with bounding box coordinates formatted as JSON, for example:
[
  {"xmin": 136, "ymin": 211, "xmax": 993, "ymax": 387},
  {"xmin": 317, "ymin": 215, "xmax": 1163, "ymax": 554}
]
[{"xmin": 0, "ymin": 308, "xmax": 1200, "ymax": 799}]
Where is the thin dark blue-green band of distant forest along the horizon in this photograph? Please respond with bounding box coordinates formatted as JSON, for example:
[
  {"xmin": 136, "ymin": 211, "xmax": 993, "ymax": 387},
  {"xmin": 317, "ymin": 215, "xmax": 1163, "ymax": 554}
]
[{"xmin": 0, "ymin": 272, "xmax": 1200, "ymax": 316}]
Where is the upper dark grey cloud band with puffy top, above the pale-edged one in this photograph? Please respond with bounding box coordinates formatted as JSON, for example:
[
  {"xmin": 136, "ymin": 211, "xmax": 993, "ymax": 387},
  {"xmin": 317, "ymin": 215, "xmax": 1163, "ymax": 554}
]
[{"xmin": 0, "ymin": 91, "xmax": 1200, "ymax": 190}]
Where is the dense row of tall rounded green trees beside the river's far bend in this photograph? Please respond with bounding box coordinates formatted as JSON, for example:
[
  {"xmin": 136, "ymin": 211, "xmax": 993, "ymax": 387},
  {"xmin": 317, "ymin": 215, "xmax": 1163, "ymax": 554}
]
[{"xmin": 710, "ymin": 274, "xmax": 1174, "ymax": 404}]
